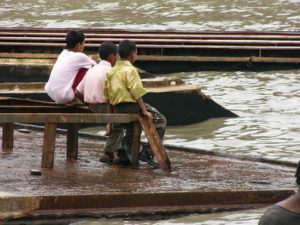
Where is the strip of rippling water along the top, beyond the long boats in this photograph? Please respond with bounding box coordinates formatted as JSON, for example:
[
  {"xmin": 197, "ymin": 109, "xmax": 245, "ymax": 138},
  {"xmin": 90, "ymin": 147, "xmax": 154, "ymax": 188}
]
[{"xmin": 0, "ymin": 0, "xmax": 300, "ymax": 31}]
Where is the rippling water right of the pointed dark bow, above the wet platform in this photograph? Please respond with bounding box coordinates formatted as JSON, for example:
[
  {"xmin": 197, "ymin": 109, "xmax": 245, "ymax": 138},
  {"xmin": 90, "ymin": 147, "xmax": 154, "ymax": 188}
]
[{"xmin": 166, "ymin": 71, "xmax": 300, "ymax": 162}]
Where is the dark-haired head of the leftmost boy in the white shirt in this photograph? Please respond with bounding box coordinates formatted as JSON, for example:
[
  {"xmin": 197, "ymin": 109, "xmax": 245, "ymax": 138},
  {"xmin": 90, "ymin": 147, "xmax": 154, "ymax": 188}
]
[{"xmin": 66, "ymin": 30, "xmax": 85, "ymax": 52}]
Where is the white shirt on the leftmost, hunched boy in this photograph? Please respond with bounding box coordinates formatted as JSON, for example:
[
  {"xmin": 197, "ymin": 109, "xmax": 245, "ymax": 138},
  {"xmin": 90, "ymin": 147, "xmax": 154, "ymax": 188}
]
[{"xmin": 45, "ymin": 49, "xmax": 96, "ymax": 104}]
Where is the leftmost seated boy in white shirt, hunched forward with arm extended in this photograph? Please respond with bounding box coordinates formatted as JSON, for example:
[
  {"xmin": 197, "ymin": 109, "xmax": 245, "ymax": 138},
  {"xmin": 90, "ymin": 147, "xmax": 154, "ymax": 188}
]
[{"xmin": 45, "ymin": 30, "xmax": 96, "ymax": 104}]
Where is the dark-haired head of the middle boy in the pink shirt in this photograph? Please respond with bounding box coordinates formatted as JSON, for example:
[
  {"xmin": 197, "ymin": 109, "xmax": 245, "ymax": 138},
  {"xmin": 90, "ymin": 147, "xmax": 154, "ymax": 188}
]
[{"xmin": 99, "ymin": 42, "xmax": 118, "ymax": 66}]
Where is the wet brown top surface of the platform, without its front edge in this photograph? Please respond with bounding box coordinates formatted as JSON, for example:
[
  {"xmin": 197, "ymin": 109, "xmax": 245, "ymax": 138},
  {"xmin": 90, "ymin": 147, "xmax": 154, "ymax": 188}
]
[{"xmin": 0, "ymin": 130, "xmax": 295, "ymax": 197}]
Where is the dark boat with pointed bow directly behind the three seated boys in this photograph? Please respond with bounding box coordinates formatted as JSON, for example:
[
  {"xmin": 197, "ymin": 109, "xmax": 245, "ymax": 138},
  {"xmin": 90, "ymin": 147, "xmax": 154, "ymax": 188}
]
[{"xmin": 0, "ymin": 79, "xmax": 238, "ymax": 126}]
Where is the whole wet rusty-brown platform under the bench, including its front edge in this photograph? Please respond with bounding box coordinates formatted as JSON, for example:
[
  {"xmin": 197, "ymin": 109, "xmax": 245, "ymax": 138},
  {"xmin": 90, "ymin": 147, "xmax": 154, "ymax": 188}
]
[{"xmin": 0, "ymin": 129, "xmax": 295, "ymax": 220}]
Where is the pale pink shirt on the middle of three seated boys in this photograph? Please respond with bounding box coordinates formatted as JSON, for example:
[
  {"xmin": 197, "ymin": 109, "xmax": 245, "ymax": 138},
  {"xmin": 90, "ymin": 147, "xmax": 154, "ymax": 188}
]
[{"xmin": 76, "ymin": 60, "xmax": 111, "ymax": 104}]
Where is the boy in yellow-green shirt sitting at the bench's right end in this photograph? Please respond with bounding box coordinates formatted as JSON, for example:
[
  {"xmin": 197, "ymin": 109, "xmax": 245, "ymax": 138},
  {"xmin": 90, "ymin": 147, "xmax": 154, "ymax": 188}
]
[{"xmin": 104, "ymin": 40, "xmax": 166, "ymax": 167}]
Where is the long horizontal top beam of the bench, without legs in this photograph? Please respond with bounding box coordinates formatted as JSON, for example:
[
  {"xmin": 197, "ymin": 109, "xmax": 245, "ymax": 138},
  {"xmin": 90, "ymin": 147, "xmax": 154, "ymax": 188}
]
[{"xmin": 0, "ymin": 113, "xmax": 138, "ymax": 123}]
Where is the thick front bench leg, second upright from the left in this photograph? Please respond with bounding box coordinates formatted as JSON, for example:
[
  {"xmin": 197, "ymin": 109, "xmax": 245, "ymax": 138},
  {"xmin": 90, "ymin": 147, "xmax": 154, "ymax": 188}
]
[{"xmin": 41, "ymin": 123, "xmax": 57, "ymax": 168}]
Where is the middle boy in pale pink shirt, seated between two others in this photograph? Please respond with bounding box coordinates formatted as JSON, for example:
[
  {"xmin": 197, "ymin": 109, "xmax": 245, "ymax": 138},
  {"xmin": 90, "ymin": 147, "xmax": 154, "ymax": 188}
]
[{"xmin": 75, "ymin": 42, "xmax": 124, "ymax": 163}]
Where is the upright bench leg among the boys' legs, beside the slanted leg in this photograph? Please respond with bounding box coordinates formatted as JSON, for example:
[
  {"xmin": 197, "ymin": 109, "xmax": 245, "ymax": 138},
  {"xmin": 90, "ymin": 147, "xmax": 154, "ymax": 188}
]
[{"xmin": 131, "ymin": 122, "xmax": 142, "ymax": 166}]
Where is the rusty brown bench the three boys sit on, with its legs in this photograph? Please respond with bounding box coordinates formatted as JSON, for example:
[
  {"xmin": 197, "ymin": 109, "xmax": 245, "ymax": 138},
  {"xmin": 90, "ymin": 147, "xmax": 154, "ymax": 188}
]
[{"xmin": 0, "ymin": 113, "xmax": 171, "ymax": 173}]
